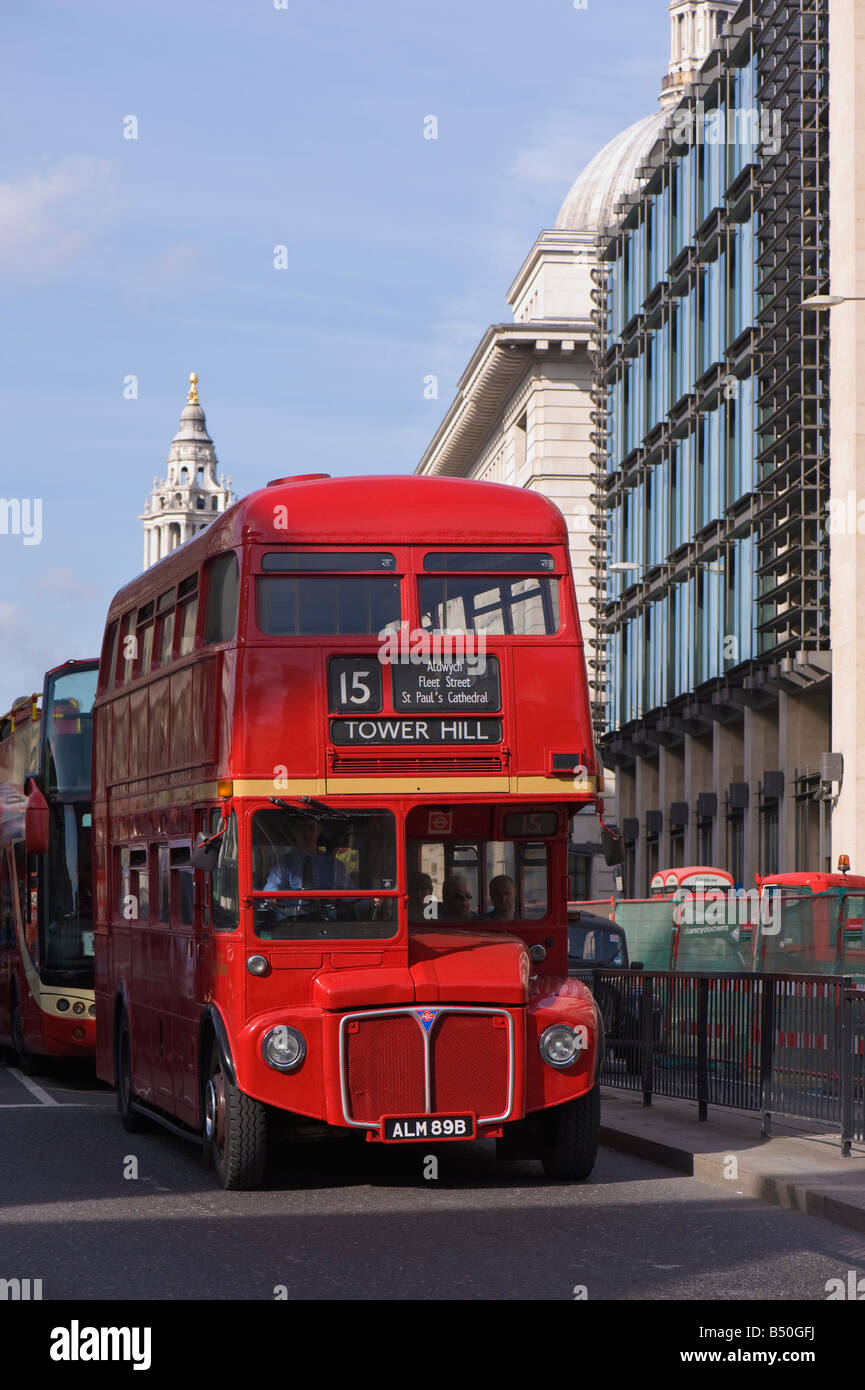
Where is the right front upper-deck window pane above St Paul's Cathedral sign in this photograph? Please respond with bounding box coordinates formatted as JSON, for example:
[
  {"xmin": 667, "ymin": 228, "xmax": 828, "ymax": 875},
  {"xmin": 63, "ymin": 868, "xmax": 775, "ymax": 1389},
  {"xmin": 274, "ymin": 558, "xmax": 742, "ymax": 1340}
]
[{"xmin": 417, "ymin": 574, "xmax": 560, "ymax": 637}]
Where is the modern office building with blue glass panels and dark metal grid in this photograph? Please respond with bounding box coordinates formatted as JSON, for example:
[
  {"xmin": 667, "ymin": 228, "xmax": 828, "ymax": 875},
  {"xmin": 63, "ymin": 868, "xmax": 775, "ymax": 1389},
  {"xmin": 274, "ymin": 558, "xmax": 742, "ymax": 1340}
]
[{"xmin": 594, "ymin": 0, "xmax": 837, "ymax": 894}]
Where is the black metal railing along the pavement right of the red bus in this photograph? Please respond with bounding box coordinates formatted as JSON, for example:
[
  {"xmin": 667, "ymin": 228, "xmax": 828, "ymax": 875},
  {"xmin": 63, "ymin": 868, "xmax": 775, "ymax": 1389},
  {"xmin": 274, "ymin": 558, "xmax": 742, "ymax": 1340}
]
[{"xmin": 577, "ymin": 970, "xmax": 865, "ymax": 1155}]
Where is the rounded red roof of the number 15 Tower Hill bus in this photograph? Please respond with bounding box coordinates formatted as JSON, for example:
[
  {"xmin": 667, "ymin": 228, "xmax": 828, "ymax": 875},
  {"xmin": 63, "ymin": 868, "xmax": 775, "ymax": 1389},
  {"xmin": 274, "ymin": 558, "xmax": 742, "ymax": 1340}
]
[{"xmin": 110, "ymin": 474, "xmax": 567, "ymax": 617}]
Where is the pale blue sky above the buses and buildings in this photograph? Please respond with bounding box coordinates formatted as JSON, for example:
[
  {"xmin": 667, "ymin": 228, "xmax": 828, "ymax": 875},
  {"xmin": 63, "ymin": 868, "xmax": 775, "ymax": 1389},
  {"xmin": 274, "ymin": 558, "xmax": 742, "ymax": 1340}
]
[{"xmin": 0, "ymin": 0, "xmax": 669, "ymax": 700}]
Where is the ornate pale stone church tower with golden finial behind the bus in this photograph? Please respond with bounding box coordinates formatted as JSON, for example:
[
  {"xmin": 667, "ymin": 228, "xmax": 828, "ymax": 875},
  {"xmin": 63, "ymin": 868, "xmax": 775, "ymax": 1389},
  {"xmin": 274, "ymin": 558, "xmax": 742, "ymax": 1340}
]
[{"xmin": 140, "ymin": 371, "xmax": 234, "ymax": 570}]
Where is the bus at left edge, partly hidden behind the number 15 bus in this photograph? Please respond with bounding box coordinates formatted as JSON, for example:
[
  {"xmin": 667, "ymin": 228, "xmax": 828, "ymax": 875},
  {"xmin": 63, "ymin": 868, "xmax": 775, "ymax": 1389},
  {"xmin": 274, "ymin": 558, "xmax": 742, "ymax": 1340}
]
[{"xmin": 0, "ymin": 660, "xmax": 99, "ymax": 1074}]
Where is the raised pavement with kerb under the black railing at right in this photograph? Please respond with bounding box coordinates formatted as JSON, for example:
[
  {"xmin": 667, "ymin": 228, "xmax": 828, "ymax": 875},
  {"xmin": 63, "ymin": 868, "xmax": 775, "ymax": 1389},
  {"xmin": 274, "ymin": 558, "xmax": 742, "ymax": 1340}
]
[{"xmin": 601, "ymin": 1086, "xmax": 865, "ymax": 1232}]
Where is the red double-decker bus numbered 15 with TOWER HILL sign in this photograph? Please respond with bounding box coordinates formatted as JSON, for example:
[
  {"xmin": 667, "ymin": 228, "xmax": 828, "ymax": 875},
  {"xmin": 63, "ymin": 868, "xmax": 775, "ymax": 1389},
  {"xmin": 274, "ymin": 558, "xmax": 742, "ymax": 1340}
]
[{"xmin": 95, "ymin": 475, "xmax": 617, "ymax": 1187}]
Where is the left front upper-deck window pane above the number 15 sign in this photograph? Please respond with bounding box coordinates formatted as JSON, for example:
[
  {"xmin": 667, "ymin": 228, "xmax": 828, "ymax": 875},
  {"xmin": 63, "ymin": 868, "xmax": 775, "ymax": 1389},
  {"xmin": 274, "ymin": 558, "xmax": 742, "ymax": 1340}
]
[{"xmin": 256, "ymin": 575, "xmax": 401, "ymax": 637}]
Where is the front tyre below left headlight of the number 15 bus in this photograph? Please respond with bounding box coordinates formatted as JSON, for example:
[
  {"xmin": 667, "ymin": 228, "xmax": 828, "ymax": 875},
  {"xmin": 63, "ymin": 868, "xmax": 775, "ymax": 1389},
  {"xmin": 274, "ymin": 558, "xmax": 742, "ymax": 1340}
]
[{"xmin": 204, "ymin": 1041, "xmax": 267, "ymax": 1191}]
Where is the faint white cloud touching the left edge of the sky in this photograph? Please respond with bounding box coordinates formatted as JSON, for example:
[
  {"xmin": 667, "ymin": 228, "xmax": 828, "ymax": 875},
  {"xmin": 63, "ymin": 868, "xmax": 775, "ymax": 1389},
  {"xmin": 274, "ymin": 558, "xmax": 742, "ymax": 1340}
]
[{"xmin": 0, "ymin": 156, "xmax": 114, "ymax": 279}]
